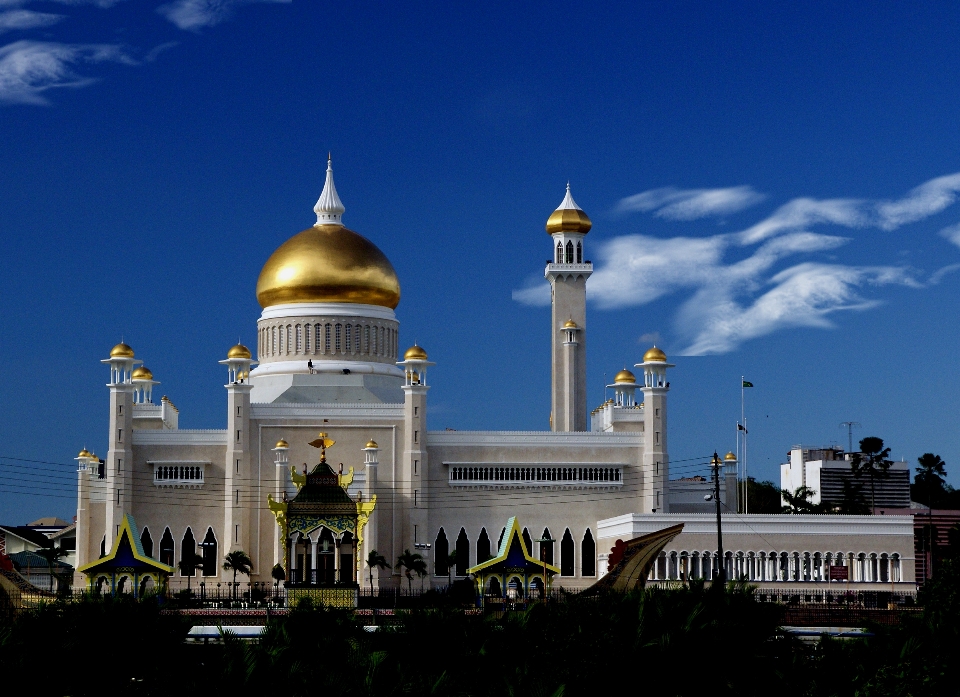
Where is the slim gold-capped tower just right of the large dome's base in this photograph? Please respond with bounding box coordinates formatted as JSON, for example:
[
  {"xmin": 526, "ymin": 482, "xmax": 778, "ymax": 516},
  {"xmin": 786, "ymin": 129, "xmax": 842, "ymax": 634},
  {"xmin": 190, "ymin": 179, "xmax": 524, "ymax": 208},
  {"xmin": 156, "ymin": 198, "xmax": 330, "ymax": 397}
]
[{"xmin": 393, "ymin": 344, "xmax": 436, "ymax": 568}]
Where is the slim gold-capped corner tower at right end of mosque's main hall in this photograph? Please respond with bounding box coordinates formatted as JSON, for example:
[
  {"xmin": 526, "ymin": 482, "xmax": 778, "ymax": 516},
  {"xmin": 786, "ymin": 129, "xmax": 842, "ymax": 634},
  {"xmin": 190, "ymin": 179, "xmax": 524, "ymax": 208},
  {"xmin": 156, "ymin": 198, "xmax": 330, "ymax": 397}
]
[{"xmin": 636, "ymin": 346, "xmax": 674, "ymax": 513}]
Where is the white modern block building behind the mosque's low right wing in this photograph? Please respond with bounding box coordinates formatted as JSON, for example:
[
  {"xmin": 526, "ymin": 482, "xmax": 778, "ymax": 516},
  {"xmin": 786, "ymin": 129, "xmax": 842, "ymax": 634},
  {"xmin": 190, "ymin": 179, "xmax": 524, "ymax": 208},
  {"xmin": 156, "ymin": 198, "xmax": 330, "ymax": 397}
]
[{"xmin": 780, "ymin": 446, "xmax": 910, "ymax": 508}]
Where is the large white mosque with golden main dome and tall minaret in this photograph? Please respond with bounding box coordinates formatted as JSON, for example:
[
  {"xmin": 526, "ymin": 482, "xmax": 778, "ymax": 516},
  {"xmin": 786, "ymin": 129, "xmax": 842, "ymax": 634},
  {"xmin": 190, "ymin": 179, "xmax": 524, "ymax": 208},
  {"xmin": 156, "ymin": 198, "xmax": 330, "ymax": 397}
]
[{"xmin": 77, "ymin": 163, "xmax": 913, "ymax": 588}]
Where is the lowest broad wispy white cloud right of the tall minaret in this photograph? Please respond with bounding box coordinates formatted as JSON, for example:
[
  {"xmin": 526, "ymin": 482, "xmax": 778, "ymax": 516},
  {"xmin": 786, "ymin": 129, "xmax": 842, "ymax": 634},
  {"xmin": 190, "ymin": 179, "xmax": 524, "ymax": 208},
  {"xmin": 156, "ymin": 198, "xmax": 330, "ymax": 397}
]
[{"xmin": 678, "ymin": 263, "xmax": 918, "ymax": 356}]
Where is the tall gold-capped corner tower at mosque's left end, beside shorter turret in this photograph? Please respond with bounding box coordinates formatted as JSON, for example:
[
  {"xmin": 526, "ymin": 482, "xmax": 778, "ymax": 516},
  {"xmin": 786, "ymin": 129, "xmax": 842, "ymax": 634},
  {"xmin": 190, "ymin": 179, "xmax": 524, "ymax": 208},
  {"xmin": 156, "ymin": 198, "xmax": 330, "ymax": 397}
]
[{"xmin": 101, "ymin": 342, "xmax": 143, "ymax": 548}]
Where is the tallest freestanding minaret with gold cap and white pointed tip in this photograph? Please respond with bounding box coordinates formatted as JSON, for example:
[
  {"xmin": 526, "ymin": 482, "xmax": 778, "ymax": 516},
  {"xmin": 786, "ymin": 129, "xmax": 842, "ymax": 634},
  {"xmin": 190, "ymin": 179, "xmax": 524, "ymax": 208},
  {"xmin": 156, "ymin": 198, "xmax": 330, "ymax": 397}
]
[{"xmin": 544, "ymin": 188, "xmax": 593, "ymax": 431}]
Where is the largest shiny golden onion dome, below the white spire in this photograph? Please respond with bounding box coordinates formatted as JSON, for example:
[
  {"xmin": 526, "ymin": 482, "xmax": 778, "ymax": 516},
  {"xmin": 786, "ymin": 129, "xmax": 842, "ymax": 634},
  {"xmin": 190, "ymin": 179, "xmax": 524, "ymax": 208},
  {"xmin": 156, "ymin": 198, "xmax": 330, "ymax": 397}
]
[{"xmin": 257, "ymin": 225, "xmax": 400, "ymax": 309}]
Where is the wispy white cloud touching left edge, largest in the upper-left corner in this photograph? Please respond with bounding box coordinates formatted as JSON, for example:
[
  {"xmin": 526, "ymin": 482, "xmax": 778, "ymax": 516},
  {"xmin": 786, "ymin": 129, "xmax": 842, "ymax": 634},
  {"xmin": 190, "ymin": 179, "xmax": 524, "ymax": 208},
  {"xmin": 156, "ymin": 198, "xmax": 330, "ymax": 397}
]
[{"xmin": 0, "ymin": 41, "xmax": 134, "ymax": 104}]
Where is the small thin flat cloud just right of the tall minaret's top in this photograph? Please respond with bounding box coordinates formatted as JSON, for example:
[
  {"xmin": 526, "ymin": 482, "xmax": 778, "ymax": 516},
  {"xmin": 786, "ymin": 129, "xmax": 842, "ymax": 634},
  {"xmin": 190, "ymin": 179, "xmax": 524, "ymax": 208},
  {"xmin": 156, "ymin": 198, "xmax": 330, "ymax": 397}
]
[{"xmin": 616, "ymin": 186, "xmax": 765, "ymax": 220}]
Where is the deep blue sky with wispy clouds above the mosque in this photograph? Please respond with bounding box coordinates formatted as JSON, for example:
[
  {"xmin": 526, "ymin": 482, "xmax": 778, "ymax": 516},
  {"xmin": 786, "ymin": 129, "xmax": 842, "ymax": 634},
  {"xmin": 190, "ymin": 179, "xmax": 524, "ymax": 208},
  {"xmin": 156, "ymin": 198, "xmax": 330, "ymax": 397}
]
[{"xmin": 0, "ymin": 0, "xmax": 960, "ymax": 523}]
